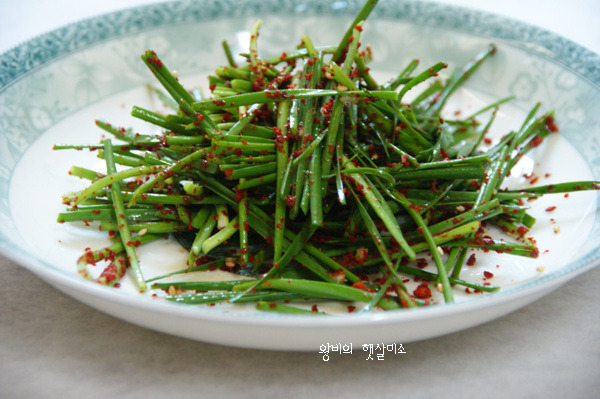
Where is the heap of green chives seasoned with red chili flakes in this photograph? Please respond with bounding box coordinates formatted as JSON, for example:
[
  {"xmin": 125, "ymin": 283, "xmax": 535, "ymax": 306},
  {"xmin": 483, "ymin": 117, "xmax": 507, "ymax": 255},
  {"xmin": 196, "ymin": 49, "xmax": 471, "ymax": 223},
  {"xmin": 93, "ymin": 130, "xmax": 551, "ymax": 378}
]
[{"xmin": 55, "ymin": 1, "xmax": 599, "ymax": 315}]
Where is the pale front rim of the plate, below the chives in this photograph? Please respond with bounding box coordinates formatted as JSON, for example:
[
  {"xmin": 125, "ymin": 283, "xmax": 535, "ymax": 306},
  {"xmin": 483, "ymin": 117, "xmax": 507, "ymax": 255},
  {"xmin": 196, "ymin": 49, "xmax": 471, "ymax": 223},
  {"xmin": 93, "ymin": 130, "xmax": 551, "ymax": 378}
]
[{"xmin": 0, "ymin": 242, "xmax": 598, "ymax": 329}]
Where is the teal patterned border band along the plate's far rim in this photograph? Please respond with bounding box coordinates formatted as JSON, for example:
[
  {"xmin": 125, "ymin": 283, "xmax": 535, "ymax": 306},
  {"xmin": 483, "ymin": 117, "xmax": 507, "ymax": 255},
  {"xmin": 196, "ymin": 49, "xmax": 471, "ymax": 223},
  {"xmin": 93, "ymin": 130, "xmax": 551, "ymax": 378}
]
[{"xmin": 0, "ymin": 0, "xmax": 600, "ymax": 92}]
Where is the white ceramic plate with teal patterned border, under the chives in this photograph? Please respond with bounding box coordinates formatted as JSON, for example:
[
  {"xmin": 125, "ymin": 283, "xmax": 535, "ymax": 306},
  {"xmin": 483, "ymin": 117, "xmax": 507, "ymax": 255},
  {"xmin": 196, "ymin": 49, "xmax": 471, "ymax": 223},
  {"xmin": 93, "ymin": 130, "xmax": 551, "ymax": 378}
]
[{"xmin": 0, "ymin": 0, "xmax": 600, "ymax": 350}]
